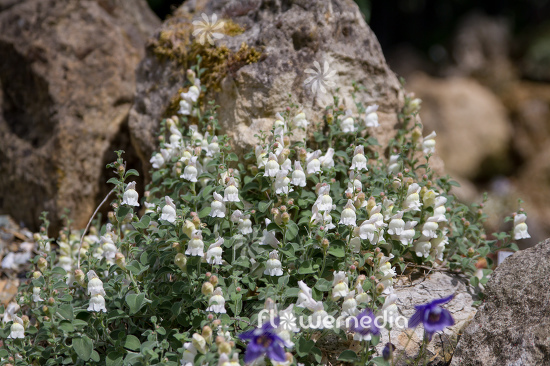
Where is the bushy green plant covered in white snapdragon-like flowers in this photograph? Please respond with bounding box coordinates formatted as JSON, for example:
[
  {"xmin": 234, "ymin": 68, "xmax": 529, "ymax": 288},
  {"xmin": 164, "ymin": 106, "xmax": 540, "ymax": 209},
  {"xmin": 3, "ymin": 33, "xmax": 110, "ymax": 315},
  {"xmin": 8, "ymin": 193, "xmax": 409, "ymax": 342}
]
[{"xmin": 0, "ymin": 58, "xmax": 528, "ymax": 365}]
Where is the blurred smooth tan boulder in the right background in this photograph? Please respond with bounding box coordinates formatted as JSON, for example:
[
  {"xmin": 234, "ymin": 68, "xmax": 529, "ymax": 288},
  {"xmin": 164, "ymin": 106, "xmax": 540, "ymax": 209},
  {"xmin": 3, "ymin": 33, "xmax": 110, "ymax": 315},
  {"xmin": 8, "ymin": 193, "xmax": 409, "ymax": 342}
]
[{"xmin": 407, "ymin": 74, "xmax": 512, "ymax": 179}]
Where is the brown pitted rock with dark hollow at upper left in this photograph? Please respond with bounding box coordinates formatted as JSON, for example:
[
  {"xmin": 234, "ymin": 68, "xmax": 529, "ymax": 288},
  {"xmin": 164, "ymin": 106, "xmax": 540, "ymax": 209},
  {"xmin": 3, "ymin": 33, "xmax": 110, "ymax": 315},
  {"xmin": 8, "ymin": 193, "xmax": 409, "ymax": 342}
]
[{"xmin": 0, "ymin": 0, "xmax": 158, "ymax": 232}]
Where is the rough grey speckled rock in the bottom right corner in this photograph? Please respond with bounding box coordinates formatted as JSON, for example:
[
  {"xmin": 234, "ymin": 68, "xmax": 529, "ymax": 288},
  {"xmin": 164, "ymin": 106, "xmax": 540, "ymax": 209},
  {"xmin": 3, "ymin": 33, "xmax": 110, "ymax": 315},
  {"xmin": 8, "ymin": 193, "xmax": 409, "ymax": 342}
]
[{"xmin": 451, "ymin": 239, "xmax": 550, "ymax": 366}]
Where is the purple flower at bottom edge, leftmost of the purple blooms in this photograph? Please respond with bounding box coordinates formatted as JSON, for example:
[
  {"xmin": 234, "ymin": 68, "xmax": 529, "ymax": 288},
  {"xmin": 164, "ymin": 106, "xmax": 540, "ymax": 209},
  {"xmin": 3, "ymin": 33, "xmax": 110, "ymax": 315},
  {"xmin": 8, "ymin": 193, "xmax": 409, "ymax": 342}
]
[{"xmin": 239, "ymin": 318, "xmax": 286, "ymax": 363}]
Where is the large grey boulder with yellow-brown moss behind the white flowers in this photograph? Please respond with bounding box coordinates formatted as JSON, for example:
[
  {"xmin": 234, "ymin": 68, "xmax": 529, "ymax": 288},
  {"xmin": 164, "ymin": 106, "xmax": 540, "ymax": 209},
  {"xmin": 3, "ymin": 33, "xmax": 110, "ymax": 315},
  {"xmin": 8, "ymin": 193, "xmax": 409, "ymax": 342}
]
[{"xmin": 129, "ymin": 0, "xmax": 402, "ymax": 169}]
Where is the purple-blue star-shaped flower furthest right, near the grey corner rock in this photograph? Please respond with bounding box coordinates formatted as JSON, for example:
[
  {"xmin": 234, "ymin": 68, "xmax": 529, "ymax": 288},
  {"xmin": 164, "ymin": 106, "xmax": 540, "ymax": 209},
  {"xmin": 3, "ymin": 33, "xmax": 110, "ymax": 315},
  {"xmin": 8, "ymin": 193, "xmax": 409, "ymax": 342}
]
[{"xmin": 409, "ymin": 295, "xmax": 455, "ymax": 341}]
